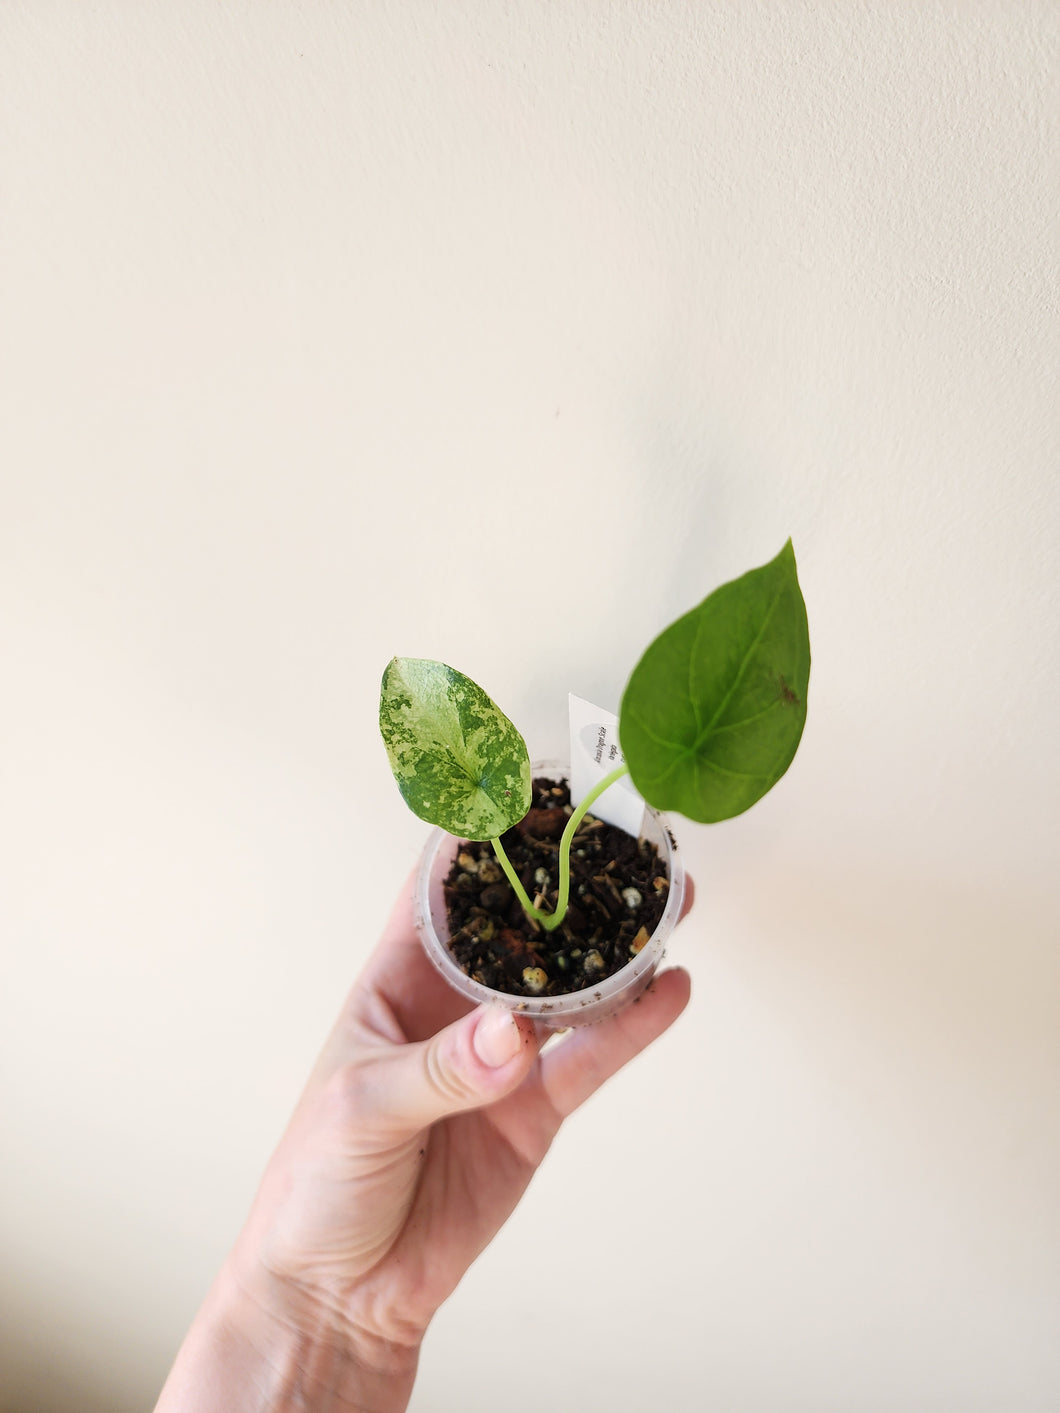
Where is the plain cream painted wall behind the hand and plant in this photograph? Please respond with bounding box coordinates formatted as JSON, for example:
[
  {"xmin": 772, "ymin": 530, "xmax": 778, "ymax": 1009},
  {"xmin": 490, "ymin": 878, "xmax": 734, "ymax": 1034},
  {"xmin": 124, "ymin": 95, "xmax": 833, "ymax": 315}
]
[{"xmin": 0, "ymin": 8, "xmax": 1060, "ymax": 1413}]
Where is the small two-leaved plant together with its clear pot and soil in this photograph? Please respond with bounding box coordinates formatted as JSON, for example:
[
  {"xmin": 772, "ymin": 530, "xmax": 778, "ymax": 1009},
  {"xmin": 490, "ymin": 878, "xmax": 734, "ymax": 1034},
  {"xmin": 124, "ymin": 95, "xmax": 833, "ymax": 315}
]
[{"xmin": 379, "ymin": 540, "xmax": 810, "ymax": 1029}]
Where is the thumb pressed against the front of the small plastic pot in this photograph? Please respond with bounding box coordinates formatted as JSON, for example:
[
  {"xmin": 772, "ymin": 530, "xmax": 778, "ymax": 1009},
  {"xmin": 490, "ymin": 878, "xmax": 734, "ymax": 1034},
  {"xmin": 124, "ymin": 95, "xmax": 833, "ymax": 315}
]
[{"xmin": 379, "ymin": 1006, "xmax": 538, "ymax": 1133}]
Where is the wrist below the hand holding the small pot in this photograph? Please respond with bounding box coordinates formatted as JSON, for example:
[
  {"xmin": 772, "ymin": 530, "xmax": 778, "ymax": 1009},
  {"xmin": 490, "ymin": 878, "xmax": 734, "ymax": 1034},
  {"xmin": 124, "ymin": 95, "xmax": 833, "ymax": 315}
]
[{"xmin": 155, "ymin": 1263, "xmax": 420, "ymax": 1413}]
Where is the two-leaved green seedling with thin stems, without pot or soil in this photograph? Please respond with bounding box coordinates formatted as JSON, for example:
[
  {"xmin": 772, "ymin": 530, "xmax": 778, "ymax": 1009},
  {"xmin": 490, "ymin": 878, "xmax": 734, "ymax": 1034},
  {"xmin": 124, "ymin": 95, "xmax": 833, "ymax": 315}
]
[{"xmin": 379, "ymin": 540, "xmax": 810, "ymax": 931}]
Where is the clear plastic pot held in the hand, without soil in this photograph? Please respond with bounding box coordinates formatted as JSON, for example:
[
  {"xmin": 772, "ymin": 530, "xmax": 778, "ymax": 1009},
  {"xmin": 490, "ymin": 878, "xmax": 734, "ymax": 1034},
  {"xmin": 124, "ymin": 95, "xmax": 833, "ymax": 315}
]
[{"xmin": 416, "ymin": 760, "xmax": 684, "ymax": 1030}]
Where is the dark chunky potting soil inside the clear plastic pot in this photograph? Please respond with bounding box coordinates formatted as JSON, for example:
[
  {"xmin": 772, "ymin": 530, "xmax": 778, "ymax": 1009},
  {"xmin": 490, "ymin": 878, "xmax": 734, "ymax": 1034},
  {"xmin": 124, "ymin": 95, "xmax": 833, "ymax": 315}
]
[{"xmin": 444, "ymin": 779, "xmax": 670, "ymax": 996}]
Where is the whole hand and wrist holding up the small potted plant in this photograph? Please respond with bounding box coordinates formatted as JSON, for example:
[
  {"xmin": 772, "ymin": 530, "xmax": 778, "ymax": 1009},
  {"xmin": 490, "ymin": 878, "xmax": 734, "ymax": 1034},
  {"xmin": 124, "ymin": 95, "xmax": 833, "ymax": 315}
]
[{"xmin": 157, "ymin": 864, "xmax": 691, "ymax": 1413}]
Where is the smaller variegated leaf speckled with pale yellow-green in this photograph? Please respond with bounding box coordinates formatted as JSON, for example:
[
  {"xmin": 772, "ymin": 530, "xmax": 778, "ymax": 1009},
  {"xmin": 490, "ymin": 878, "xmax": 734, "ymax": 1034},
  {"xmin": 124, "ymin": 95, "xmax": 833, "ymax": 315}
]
[{"xmin": 379, "ymin": 657, "xmax": 531, "ymax": 839}]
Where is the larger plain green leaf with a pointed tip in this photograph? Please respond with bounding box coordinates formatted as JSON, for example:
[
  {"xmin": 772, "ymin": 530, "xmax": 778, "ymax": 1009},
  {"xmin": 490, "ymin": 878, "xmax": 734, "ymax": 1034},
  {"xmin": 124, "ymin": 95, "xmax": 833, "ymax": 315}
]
[{"xmin": 619, "ymin": 540, "xmax": 810, "ymax": 824}]
